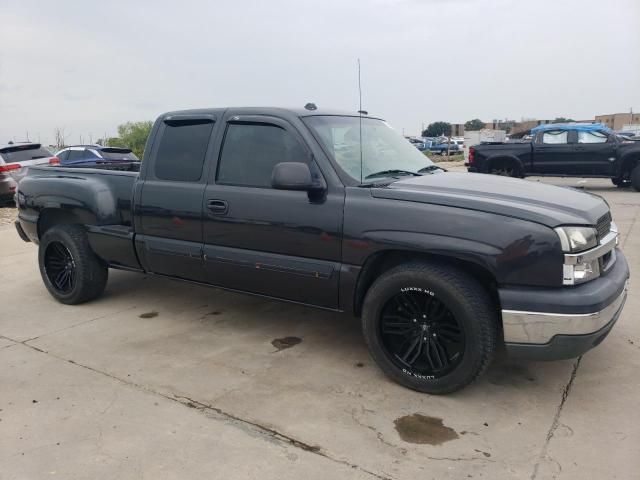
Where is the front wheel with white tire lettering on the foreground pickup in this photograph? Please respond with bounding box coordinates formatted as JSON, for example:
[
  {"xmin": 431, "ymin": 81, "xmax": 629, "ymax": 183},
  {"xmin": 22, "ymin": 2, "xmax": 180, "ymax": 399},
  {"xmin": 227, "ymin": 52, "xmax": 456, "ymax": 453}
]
[{"xmin": 362, "ymin": 263, "xmax": 498, "ymax": 394}]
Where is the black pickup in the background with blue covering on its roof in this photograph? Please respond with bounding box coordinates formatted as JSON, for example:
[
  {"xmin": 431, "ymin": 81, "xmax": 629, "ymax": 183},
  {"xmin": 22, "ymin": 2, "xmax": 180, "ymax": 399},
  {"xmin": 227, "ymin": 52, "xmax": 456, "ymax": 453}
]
[{"xmin": 466, "ymin": 124, "xmax": 640, "ymax": 191}]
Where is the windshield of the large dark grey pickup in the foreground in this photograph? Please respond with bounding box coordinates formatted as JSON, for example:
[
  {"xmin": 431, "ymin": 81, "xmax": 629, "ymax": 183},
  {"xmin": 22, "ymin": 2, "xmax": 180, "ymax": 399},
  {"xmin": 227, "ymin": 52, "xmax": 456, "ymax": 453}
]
[{"xmin": 303, "ymin": 115, "xmax": 435, "ymax": 182}]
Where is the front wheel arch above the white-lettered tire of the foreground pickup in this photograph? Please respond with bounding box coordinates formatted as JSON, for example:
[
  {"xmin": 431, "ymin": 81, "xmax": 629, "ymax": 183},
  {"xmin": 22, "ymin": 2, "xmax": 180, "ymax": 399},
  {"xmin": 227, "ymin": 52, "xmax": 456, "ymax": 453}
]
[{"xmin": 353, "ymin": 250, "xmax": 500, "ymax": 317}]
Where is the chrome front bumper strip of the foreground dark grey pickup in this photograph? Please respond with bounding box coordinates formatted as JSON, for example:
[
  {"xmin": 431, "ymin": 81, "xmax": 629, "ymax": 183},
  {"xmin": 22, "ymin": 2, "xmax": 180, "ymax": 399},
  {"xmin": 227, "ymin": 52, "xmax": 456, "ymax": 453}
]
[{"xmin": 502, "ymin": 282, "xmax": 628, "ymax": 344}]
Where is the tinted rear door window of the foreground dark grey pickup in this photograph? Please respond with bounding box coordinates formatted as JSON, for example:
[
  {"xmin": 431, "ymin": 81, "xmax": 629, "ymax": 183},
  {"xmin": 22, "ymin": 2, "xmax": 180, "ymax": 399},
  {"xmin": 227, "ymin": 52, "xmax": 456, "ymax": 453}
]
[{"xmin": 155, "ymin": 120, "xmax": 213, "ymax": 182}]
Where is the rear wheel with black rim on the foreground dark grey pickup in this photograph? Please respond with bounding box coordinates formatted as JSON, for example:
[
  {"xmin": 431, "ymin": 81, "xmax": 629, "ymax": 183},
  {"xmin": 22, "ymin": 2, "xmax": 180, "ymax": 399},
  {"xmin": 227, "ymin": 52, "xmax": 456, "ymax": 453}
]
[{"xmin": 38, "ymin": 225, "xmax": 109, "ymax": 305}]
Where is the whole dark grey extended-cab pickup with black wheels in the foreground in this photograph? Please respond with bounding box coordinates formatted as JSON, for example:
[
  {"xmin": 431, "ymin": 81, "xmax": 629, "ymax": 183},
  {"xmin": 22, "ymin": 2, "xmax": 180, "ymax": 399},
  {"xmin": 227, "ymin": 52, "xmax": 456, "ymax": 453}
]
[{"xmin": 16, "ymin": 107, "xmax": 629, "ymax": 393}]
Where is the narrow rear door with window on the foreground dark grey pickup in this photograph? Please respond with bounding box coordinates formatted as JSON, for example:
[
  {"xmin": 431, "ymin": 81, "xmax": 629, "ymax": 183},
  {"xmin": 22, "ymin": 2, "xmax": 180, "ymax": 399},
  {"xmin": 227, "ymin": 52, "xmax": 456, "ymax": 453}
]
[{"xmin": 136, "ymin": 115, "xmax": 215, "ymax": 281}]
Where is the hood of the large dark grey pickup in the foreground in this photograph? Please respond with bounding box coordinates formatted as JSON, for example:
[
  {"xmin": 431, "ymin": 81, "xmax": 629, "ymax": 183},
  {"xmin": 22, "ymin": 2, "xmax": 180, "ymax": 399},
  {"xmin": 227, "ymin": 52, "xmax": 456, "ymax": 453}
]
[{"xmin": 371, "ymin": 172, "xmax": 609, "ymax": 228}]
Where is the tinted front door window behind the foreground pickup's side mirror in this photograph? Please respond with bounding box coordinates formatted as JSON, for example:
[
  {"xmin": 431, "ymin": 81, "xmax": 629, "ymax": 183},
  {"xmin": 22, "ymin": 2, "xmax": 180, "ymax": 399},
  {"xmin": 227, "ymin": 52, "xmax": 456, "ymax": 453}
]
[{"xmin": 216, "ymin": 124, "xmax": 308, "ymax": 187}]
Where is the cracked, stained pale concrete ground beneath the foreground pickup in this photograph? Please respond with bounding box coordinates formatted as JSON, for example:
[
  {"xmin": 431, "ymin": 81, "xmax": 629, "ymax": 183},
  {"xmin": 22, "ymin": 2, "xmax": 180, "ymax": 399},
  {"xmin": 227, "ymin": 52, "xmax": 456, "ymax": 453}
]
[{"xmin": 0, "ymin": 179, "xmax": 640, "ymax": 480}]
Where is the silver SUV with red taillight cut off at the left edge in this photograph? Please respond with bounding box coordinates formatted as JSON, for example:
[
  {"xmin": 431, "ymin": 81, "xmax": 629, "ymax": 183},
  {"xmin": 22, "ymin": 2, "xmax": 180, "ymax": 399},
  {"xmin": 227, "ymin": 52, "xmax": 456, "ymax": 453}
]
[{"xmin": 0, "ymin": 142, "xmax": 59, "ymax": 206}]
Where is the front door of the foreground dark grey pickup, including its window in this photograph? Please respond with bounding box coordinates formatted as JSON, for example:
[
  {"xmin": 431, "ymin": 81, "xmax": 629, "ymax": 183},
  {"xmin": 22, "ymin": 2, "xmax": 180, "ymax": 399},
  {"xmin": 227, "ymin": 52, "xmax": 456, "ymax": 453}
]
[{"xmin": 203, "ymin": 110, "xmax": 344, "ymax": 308}]
